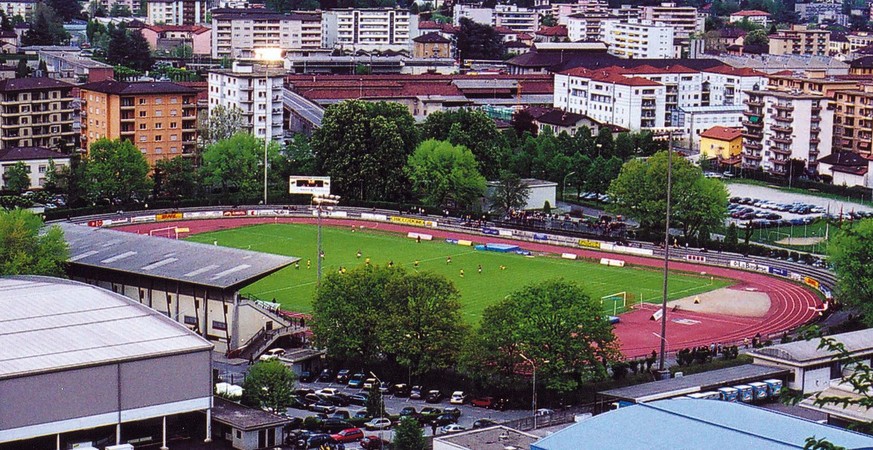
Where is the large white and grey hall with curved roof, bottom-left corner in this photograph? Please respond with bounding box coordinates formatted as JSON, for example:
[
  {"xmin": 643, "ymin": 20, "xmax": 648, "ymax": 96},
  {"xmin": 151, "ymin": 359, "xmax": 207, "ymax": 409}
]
[{"xmin": 0, "ymin": 276, "xmax": 212, "ymax": 449}]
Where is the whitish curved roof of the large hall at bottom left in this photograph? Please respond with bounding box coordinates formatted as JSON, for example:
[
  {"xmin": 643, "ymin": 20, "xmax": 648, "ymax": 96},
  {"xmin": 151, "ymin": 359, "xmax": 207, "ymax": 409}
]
[{"xmin": 0, "ymin": 276, "xmax": 212, "ymax": 379}]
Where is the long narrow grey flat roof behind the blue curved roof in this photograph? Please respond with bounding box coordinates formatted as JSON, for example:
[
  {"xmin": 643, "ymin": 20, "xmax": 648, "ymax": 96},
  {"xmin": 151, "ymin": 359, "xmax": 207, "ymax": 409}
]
[{"xmin": 598, "ymin": 364, "xmax": 789, "ymax": 403}]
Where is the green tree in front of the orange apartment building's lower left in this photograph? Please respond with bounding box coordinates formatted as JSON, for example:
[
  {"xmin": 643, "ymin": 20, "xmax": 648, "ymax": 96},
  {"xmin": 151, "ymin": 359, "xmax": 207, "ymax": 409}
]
[{"xmin": 84, "ymin": 138, "xmax": 152, "ymax": 204}]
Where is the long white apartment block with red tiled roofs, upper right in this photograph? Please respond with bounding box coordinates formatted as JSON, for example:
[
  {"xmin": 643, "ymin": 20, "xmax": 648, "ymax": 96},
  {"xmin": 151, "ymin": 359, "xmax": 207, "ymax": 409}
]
[{"xmin": 554, "ymin": 65, "xmax": 767, "ymax": 131}]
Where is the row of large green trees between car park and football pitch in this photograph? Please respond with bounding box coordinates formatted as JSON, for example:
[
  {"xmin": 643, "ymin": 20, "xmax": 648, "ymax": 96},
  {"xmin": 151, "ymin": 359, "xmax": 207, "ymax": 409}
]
[{"xmin": 311, "ymin": 265, "xmax": 619, "ymax": 392}]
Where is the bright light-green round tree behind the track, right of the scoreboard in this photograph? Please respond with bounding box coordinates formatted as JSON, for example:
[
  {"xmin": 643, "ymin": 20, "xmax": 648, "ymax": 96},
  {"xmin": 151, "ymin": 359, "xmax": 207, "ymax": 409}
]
[{"xmin": 405, "ymin": 139, "xmax": 485, "ymax": 208}]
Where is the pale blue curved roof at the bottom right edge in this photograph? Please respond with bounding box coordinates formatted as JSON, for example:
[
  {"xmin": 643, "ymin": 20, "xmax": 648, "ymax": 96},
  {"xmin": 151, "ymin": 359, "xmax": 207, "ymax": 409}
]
[{"xmin": 531, "ymin": 399, "xmax": 873, "ymax": 450}]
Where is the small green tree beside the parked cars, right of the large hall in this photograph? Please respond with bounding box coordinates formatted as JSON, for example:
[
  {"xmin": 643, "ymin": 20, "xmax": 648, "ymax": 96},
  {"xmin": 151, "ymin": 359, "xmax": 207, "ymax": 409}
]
[{"xmin": 242, "ymin": 359, "xmax": 297, "ymax": 414}]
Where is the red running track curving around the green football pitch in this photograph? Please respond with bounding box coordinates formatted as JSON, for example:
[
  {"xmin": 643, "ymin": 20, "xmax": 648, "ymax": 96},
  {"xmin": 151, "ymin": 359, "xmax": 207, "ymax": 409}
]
[{"xmin": 118, "ymin": 217, "xmax": 821, "ymax": 358}]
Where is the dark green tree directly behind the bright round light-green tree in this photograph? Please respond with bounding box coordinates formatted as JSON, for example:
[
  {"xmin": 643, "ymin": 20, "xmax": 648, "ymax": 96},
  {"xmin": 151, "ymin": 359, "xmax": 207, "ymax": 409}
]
[{"xmin": 421, "ymin": 109, "xmax": 502, "ymax": 179}]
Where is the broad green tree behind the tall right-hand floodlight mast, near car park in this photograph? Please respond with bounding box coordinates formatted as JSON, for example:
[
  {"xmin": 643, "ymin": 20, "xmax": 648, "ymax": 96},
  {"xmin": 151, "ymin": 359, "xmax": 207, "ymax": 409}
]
[{"xmin": 608, "ymin": 152, "xmax": 728, "ymax": 237}]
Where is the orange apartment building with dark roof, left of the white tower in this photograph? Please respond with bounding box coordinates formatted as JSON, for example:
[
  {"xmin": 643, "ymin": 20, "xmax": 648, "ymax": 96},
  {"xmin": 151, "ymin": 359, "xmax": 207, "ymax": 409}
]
[{"xmin": 80, "ymin": 80, "xmax": 197, "ymax": 165}]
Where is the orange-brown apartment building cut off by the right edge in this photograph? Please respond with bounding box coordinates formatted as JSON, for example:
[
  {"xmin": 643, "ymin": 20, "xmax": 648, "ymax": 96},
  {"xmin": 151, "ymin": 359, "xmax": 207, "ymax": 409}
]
[{"xmin": 834, "ymin": 84, "xmax": 873, "ymax": 157}]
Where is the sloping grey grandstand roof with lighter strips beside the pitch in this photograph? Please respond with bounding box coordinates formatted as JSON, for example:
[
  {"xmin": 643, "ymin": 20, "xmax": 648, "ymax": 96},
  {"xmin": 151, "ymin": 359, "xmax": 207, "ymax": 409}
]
[{"xmin": 58, "ymin": 222, "xmax": 299, "ymax": 289}]
